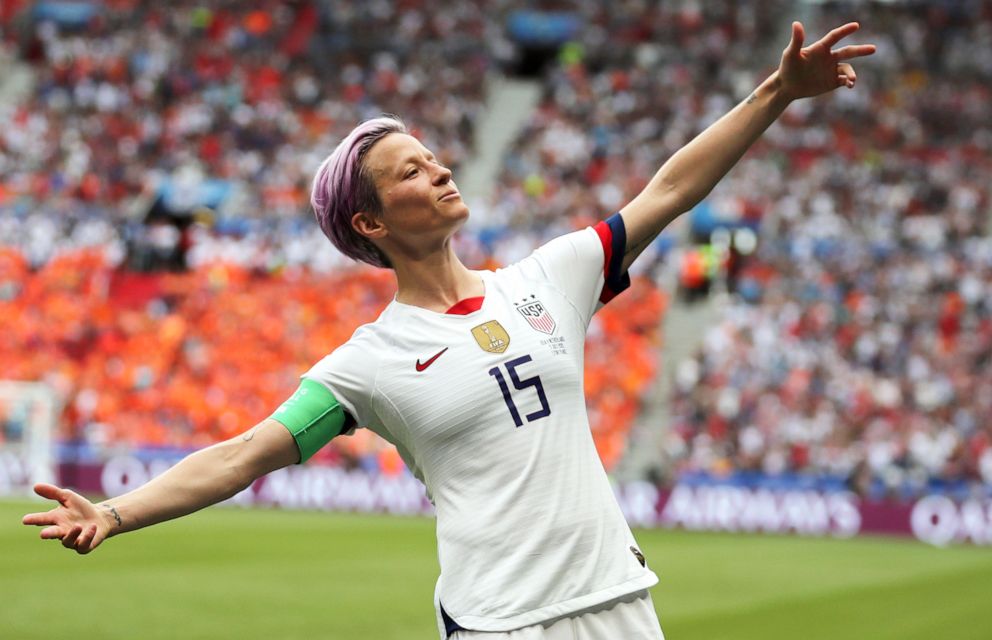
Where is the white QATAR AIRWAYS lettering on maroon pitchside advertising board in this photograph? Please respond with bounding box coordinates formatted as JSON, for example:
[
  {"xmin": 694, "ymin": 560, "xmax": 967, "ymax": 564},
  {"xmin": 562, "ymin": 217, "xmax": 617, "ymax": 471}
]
[{"xmin": 93, "ymin": 455, "xmax": 992, "ymax": 546}]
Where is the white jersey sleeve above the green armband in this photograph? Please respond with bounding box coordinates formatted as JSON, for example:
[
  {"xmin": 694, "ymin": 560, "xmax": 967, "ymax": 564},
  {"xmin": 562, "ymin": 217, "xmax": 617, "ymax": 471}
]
[{"xmin": 302, "ymin": 329, "xmax": 378, "ymax": 430}]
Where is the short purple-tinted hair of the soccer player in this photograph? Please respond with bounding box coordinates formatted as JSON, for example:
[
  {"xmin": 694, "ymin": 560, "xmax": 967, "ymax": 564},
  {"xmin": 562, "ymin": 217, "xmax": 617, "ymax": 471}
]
[{"xmin": 310, "ymin": 116, "xmax": 407, "ymax": 269}]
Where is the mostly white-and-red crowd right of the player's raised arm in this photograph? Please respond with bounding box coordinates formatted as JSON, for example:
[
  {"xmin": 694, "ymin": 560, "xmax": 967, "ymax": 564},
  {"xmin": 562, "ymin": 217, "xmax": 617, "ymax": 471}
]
[{"xmin": 665, "ymin": 3, "xmax": 992, "ymax": 497}]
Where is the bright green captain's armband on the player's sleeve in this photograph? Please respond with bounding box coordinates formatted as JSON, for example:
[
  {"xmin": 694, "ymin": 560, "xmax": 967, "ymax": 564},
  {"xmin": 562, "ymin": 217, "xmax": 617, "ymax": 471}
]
[{"xmin": 269, "ymin": 378, "xmax": 347, "ymax": 464}]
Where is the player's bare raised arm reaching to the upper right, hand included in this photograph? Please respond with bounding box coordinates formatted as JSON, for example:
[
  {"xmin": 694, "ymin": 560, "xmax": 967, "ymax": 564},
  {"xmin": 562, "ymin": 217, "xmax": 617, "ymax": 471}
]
[{"xmin": 620, "ymin": 22, "xmax": 875, "ymax": 270}]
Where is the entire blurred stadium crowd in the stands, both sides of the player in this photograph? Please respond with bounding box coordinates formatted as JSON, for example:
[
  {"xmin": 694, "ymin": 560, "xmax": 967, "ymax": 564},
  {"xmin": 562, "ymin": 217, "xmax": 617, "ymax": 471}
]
[{"xmin": 0, "ymin": 0, "xmax": 992, "ymax": 495}]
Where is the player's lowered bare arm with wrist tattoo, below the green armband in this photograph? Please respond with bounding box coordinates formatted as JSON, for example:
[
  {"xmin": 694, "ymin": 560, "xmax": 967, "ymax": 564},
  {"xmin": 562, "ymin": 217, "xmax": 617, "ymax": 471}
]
[{"xmin": 23, "ymin": 418, "xmax": 300, "ymax": 553}]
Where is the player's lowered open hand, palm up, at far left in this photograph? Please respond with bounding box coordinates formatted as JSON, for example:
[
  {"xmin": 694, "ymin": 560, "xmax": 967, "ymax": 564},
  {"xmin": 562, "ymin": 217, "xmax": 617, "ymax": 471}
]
[{"xmin": 21, "ymin": 483, "xmax": 114, "ymax": 554}]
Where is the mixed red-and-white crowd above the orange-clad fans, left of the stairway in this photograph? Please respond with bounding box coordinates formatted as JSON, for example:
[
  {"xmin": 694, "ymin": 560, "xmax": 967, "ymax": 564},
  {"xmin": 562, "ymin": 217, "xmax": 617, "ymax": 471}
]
[{"xmin": 0, "ymin": 0, "xmax": 492, "ymax": 272}]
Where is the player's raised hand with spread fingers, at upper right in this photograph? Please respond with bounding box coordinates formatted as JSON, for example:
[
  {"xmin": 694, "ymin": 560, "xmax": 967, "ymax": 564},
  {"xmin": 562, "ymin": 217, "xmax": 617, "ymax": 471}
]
[{"xmin": 778, "ymin": 22, "xmax": 875, "ymax": 100}]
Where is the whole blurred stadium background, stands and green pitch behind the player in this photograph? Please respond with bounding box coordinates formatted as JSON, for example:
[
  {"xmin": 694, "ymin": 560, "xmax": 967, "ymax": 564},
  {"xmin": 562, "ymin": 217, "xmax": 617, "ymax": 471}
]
[{"xmin": 0, "ymin": 0, "xmax": 992, "ymax": 638}]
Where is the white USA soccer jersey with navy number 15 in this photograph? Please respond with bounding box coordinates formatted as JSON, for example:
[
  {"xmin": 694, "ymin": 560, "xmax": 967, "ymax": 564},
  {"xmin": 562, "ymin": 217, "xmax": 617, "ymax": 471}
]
[{"xmin": 304, "ymin": 214, "xmax": 657, "ymax": 637}]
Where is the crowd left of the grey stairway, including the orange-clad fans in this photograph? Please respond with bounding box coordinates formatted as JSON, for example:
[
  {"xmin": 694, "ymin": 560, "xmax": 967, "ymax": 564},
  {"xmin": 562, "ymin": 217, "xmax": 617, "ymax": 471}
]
[{"xmin": 0, "ymin": 2, "xmax": 664, "ymax": 472}]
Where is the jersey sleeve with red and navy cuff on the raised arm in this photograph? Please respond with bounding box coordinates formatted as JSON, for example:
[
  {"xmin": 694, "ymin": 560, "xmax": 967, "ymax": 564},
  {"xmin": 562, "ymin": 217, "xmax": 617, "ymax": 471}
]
[{"xmin": 516, "ymin": 213, "xmax": 630, "ymax": 324}]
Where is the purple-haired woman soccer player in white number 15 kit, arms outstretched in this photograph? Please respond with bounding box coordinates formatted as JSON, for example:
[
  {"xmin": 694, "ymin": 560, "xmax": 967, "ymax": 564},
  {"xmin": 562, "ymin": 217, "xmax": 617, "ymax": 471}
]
[{"xmin": 24, "ymin": 22, "xmax": 874, "ymax": 640}]
